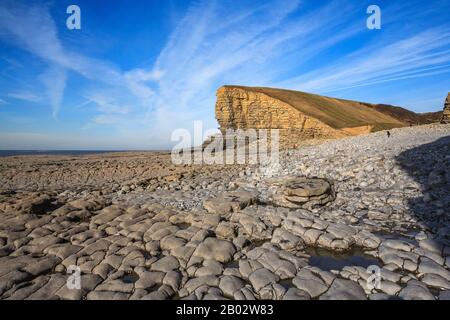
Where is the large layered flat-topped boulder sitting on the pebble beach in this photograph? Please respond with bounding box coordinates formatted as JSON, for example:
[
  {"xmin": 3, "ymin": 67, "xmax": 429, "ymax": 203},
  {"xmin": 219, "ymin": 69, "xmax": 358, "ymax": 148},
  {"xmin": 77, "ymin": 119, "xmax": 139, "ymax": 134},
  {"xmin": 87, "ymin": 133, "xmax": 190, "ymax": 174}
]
[{"xmin": 266, "ymin": 176, "xmax": 335, "ymax": 209}]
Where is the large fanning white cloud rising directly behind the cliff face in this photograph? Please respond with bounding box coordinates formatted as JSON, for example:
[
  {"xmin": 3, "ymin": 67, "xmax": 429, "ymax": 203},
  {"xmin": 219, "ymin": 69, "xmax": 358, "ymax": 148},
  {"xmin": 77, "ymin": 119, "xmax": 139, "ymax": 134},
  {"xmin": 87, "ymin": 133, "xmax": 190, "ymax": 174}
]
[{"xmin": 139, "ymin": 0, "xmax": 368, "ymax": 144}]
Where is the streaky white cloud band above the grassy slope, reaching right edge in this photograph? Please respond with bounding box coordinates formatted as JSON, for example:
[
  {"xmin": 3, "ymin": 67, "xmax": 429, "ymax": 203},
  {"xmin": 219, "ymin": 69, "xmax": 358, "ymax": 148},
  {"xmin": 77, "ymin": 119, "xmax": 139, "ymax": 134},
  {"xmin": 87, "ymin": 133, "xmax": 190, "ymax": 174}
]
[{"xmin": 279, "ymin": 29, "xmax": 450, "ymax": 93}]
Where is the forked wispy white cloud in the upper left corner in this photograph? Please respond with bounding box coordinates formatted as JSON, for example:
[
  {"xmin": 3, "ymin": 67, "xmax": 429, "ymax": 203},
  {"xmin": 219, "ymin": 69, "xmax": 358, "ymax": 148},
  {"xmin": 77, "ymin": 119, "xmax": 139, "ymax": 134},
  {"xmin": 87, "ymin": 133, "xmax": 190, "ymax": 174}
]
[{"xmin": 0, "ymin": 1, "xmax": 158, "ymax": 117}]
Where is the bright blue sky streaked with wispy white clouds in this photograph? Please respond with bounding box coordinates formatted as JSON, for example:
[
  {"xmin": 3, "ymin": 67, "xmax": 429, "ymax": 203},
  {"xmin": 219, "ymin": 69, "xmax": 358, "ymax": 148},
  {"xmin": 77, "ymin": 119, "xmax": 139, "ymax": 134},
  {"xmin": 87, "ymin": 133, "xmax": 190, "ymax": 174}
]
[{"xmin": 0, "ymin": 0, "xmax": 450, "ymax": 150}]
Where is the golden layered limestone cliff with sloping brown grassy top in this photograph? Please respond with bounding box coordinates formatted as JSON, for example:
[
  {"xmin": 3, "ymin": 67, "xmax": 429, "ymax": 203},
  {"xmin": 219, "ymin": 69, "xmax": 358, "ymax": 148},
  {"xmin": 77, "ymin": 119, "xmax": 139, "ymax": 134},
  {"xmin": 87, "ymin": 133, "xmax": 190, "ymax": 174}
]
[{"xmin": 215, "ymin": 86, "xmax": 414, "ymax": 146}]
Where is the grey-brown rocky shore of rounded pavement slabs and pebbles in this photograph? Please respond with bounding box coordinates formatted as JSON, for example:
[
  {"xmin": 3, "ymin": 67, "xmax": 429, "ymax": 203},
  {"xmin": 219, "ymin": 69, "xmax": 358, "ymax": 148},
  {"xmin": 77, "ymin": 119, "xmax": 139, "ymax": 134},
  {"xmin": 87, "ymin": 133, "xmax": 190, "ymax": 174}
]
[{"xmin": 0, "ymin": 125, "xmax": 450, "ymax": 300}]
